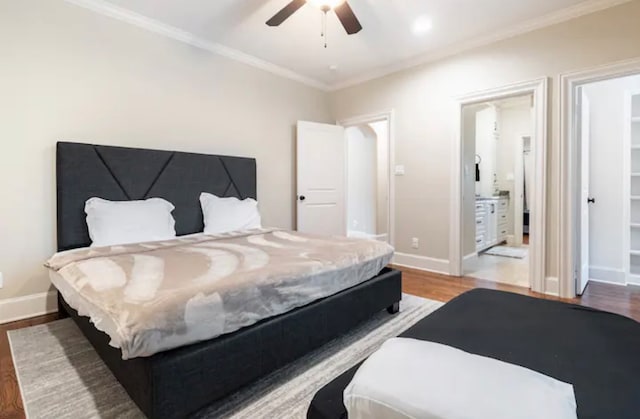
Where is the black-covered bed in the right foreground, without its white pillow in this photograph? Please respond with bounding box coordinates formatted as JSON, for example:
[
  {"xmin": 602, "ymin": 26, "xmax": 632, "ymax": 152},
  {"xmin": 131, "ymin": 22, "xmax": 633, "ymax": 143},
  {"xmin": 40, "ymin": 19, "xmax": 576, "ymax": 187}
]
[{"xmin": 308, "ymin": 289, "xmax": 640, "ymax": 419}]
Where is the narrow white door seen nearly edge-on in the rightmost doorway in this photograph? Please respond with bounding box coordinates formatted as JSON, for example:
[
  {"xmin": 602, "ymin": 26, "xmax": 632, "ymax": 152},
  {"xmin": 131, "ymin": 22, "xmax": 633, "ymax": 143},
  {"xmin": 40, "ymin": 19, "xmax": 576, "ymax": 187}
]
[{"xmin": 576, "ymin": 89, "xmax": 591, "ymax": 295}]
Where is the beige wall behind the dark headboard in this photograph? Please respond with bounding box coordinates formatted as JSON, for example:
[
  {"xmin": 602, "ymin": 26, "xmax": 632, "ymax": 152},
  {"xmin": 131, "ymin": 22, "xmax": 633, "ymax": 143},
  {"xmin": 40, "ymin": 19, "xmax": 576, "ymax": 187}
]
[{"xmin": 0, "ymin": 0, "xmax": 332, "ymax": 304}]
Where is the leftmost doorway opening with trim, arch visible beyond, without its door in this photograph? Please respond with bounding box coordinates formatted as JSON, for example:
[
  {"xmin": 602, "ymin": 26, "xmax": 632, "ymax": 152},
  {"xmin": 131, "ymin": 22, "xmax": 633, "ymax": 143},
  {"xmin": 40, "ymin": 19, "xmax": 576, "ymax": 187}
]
[{"xmin": 339, "ymin": 112, "xmax": 392, "ymax": 243}]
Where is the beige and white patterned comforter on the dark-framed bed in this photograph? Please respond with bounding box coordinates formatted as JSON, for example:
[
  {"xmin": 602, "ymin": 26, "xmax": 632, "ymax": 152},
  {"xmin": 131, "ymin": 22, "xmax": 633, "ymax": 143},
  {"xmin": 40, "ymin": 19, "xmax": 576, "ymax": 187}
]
[{"xmin": 46, "ymin": 229, "xmax": 393, "ymax": 359}]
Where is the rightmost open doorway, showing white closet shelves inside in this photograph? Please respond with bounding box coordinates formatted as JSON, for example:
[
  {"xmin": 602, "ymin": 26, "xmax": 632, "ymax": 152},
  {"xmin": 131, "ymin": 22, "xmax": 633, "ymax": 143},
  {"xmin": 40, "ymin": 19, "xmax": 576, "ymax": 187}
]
[{"xmin": 572, "ymin": 75, "xmax": 640, "ymax": 295}]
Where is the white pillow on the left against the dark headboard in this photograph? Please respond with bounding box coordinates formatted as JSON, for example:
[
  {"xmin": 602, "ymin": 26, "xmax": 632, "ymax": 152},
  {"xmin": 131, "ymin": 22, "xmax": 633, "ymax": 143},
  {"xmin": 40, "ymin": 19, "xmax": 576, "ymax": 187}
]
[{"xmin": 84, "ymin": 198, "xmax": 176, "ymax": 246}]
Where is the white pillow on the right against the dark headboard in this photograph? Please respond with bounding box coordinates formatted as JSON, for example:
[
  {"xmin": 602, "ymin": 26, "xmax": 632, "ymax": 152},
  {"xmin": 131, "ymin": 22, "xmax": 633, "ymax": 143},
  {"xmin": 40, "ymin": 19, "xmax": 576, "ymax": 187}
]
[{"xmin": 200, "ymin": 192, "xmax": 261, "ymax": 234}]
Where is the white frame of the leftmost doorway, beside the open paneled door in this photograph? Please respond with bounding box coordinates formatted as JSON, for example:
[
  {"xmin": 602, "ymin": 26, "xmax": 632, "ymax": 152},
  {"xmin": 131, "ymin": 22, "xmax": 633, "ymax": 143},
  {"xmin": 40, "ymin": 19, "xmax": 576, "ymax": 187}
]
[{"xmin": 336, "ymin": 109, "xmax": 396, "ymax": 246}]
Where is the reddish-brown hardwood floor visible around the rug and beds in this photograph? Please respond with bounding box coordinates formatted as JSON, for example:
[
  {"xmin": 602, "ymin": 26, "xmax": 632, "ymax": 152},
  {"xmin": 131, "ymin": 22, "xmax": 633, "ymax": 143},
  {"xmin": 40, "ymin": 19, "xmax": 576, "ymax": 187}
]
[{"xmin": 0, "ymin": 268, "xmax": 640, "ymax": 419}]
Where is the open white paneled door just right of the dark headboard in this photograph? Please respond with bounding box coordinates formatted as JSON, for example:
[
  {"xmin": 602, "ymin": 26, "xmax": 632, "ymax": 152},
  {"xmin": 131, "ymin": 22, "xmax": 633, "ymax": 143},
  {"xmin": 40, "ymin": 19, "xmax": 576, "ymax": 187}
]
[{"xmin": 297, "ymin": 121, "xmax": 347, "ymax": 236}]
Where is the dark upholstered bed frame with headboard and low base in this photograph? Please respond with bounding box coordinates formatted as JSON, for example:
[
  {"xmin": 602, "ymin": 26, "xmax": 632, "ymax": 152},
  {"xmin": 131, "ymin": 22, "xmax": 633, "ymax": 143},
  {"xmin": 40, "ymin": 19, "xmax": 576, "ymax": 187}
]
[{"xmin": 56, "ymin": 142, "xmax": 402, "ymax": 419}]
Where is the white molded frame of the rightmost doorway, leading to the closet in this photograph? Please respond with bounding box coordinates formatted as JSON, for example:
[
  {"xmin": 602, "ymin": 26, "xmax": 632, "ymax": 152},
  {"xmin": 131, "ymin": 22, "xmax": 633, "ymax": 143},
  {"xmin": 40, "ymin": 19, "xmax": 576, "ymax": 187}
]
[{"xmin": 556, "ymin": 59, "xmax": 640, "ymax": 298}]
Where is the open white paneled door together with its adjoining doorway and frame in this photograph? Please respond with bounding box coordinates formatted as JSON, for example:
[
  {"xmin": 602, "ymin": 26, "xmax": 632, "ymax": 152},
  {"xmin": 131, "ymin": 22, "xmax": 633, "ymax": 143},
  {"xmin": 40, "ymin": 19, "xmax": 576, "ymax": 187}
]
[{"xmin": 296, "ymin": 111, "xmax": 394, "ymax": 244}]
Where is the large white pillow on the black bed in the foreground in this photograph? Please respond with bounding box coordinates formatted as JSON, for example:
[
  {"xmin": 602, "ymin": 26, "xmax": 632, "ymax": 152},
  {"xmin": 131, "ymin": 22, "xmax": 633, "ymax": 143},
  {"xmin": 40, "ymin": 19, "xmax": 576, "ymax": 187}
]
[{"xmin": 344, "ymin": 338, "xmax": 577, "ymax": 419}]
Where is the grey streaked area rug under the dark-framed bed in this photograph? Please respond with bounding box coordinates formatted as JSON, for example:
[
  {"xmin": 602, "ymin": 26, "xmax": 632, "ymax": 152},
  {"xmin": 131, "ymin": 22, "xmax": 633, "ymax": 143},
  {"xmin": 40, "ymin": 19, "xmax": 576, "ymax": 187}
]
[{"xmin": 9, "ymin": 294, "xmax": 442, "ymax": 419}]
